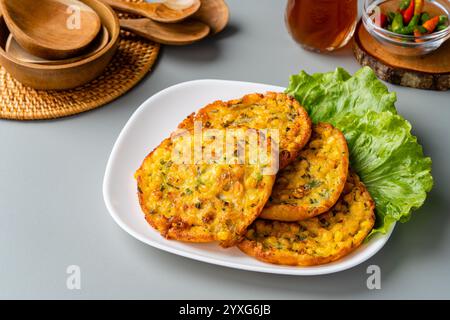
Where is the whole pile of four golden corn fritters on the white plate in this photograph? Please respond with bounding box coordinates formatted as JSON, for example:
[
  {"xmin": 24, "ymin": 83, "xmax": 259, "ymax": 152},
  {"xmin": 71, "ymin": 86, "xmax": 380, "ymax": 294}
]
[{"xmin": 135, "ymin": 92, "xmax": 375, "ymax": 266}]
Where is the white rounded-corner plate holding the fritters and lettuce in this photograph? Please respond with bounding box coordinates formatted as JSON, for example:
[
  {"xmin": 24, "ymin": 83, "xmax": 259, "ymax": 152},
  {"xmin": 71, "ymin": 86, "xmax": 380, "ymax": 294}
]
[{"xmin": 103, "ymin": 80, "xmax": 393, "ymax": 275}]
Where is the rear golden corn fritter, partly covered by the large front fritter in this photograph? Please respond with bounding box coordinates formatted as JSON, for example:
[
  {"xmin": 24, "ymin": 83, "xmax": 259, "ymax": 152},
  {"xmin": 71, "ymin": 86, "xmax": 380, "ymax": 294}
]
[{"xmin": 194, "ymin": 92, "xmax": 312, "ymax": 169}]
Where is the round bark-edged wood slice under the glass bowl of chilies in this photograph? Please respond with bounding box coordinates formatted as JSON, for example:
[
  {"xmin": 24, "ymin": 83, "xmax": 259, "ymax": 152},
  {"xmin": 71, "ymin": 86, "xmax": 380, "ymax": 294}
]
[{"xmin": 353, "ymin": 21, "xmax": 450, "ymax": 90}]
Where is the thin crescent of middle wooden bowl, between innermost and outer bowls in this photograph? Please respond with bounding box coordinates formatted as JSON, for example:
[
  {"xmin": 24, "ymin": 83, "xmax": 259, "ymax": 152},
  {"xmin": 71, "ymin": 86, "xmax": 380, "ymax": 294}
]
[{"xmin": 5, "ymin": 27, "xmax": 109, "ymax": 65}]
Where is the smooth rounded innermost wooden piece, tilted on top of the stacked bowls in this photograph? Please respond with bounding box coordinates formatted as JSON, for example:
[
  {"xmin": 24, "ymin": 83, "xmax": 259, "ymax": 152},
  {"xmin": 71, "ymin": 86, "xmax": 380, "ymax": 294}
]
[{"xmin": 0, "ymin": 0, "xmax": 101, "ymax": 60}]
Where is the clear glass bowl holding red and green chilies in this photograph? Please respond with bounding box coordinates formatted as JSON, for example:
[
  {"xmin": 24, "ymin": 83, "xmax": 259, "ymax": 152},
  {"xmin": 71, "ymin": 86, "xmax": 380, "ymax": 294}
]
[{"xmin": 362, "ymin": 0, "xmax": 450, "ymax": 56}]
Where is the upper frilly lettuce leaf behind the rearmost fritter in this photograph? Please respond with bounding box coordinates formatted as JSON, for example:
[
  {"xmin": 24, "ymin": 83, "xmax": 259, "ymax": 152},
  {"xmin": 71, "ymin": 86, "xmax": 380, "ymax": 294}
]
[{"xmin": 286, "ymin": 67, "xmax": 397, "ymax": 125}]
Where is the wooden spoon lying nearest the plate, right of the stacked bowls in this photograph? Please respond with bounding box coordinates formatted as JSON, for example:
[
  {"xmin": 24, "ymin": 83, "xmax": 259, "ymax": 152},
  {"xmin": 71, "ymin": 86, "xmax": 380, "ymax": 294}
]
[{"xmin": 120, "ymin": 18, "xmax": 210, "ymax": 46}]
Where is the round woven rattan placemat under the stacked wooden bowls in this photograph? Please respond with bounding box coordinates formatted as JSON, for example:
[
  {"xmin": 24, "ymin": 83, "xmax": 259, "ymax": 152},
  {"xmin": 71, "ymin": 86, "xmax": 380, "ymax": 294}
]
[{"xmin": 0, "ymin": 0, "xmax": 159, "ymax": 120}]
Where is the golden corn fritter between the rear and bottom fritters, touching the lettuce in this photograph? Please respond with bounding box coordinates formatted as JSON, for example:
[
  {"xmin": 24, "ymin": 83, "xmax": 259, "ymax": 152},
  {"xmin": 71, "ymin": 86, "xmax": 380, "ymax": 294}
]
[{"xmin": 260, "ymin": 123, "xmax": 349, "ymax": 221}]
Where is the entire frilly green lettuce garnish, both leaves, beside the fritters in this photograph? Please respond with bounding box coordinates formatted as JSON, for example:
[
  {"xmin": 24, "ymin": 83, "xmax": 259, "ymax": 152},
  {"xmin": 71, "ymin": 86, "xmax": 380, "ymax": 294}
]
[{"xmin": 286, "ymin": 67, "xmax": 433, "ymax": 235}]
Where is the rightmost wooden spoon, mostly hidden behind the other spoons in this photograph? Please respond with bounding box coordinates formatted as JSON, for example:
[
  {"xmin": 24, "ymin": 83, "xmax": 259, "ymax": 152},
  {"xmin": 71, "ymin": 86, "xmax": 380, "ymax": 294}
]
[{"xmin": 193, "ymin": 0, "xmax": 230, "ymax": 34}]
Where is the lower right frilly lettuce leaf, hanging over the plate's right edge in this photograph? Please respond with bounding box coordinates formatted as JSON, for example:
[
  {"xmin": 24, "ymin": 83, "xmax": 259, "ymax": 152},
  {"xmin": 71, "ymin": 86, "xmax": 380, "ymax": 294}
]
[{"xmin": 336, "ymin": 111, "xmax": 433, "ymax": 234}]
